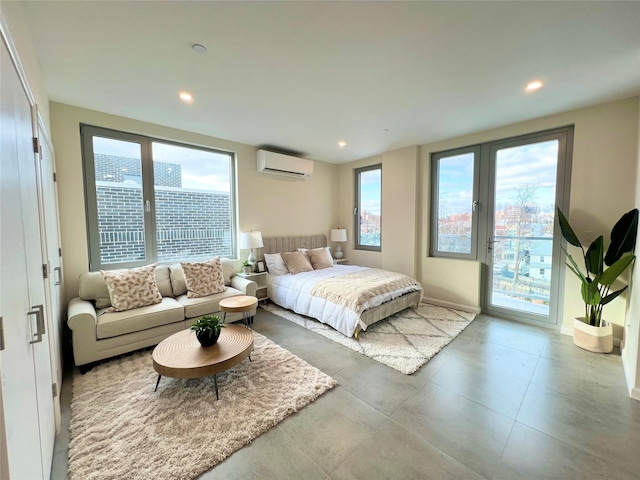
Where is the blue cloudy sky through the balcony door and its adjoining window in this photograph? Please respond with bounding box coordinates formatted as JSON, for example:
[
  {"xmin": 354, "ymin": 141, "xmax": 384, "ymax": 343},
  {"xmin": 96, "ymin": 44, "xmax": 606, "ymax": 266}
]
[{"xmin": 439, "ymin": 140, "xmax": 558, "ymax": 215}]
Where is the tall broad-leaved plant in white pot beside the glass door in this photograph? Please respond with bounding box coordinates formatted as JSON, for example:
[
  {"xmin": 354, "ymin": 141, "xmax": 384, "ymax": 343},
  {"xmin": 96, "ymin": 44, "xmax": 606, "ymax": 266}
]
[{"xmin": 558, "ymin": 208, "xmax": 638, "ymax": 353}]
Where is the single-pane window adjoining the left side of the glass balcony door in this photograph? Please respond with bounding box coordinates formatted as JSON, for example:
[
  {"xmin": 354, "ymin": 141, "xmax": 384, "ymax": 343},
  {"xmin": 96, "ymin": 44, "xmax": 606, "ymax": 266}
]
[{"xmin": 431, "ymin": 147, "xmax": 480, "ymax": 258}]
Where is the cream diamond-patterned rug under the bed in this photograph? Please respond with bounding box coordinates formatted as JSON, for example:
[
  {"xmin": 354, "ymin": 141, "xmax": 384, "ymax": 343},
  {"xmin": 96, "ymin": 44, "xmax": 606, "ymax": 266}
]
[{"xmin": 262, "ymin": 303, "xmax": 476, "ymax": 375}]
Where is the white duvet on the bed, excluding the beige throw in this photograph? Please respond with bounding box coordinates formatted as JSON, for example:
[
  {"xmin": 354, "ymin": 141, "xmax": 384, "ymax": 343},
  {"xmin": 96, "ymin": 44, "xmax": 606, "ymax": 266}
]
[{"xmin": 267, "ymin": 265, "xmax": 420, "ymax": 337}]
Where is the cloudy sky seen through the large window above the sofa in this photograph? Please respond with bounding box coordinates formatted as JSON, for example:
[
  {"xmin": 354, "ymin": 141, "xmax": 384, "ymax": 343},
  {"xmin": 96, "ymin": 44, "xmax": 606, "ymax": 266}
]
[{"xmin": 93, "ymin": 137, "xmax": 231, "ymax": 192}]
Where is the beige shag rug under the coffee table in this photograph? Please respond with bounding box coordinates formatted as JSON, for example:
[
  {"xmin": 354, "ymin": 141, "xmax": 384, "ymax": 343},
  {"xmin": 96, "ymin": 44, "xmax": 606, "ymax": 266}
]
[{"xmin": 69, "ymin": 332, "xmax": 336, "ymax": 480}]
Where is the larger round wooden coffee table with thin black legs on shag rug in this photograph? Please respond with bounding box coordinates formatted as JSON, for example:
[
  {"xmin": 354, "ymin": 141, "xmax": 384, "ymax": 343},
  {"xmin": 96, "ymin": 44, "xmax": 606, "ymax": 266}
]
[{"xmin": 152, "ymin": 325, "xmax": 253, "ymax": 399}]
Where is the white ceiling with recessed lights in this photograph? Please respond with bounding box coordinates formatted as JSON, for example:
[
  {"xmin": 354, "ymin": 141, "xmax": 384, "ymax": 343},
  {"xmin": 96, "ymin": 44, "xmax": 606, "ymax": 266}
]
[{"xmin": 24, "ymin": 1, "xmax": 640, "ymax": 163}]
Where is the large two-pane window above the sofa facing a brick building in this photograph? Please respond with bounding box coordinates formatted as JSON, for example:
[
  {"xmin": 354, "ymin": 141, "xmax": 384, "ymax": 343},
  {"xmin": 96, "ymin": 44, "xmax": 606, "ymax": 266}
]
[{"xmin": 81, "ymin": 125, "xmax": 236, "ymax": 271}]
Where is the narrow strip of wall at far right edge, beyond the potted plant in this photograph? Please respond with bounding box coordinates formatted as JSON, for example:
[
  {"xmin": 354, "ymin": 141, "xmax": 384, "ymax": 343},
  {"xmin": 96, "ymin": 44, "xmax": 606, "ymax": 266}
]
[{"xmin": 622, "ymin": 99, "xmax": 640, "ymax": 400}]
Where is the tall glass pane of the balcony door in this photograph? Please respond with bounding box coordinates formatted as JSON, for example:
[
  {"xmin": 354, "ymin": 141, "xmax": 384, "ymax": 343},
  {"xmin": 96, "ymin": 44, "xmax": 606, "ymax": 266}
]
[{"xmin": 486, "ymin": 139, "xmax": 560, "ymax": 321}]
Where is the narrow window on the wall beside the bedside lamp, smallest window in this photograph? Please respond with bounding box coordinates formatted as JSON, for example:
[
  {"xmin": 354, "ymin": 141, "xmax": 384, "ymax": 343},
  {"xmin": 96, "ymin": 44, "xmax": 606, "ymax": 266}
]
[{"xmin": 354, "ymin": 165, "xmax": 382, "ymax": 252}]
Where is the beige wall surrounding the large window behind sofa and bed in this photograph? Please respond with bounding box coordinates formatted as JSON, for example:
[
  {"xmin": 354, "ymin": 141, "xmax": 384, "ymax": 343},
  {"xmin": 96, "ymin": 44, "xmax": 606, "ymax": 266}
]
[{"xmin": 50, "ymin": 102, "xmax": 338, "ymax": 301}]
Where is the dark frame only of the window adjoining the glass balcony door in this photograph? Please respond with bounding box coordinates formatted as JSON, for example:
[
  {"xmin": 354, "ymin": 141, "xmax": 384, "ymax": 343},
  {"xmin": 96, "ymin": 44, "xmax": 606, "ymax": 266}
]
[{"xmin": 429, "ymin": 145, "xmax": 480, "ymax": 260}]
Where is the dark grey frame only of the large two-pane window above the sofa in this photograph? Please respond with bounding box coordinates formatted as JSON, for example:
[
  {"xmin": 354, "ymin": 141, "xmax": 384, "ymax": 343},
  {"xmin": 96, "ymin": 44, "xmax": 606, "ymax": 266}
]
[{"xmin": 80, "ymin": 123, "xmax": 238, "ymax": 271}]
